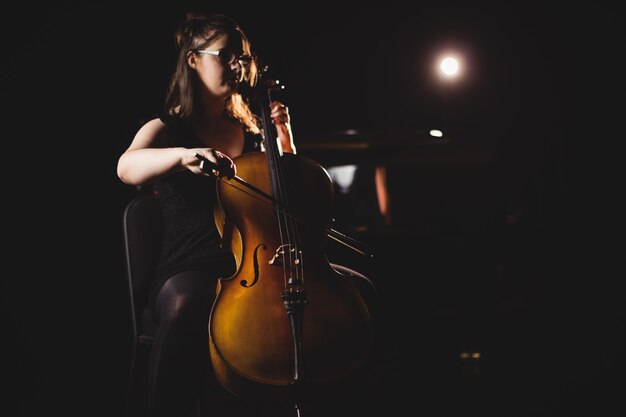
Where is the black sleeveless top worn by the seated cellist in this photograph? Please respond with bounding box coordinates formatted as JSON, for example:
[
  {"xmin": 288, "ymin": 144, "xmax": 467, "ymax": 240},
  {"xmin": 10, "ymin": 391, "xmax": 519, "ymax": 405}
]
[{"xmin": 150, "ymin": 116, "xmax": 262, "ymax": 311}]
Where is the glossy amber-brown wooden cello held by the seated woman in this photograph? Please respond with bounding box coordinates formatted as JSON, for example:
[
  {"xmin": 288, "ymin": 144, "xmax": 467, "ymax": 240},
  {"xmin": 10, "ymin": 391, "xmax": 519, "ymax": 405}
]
[{"xmin": 209, "ymin": 66, "xmax": 373, "ymax": 399}]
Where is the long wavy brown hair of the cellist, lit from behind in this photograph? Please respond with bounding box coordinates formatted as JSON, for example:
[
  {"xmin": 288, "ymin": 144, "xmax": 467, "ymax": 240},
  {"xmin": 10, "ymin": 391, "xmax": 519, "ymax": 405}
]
[{"xmin": 164, "ymin": 12, "xmax": 260, "ymax": 133}]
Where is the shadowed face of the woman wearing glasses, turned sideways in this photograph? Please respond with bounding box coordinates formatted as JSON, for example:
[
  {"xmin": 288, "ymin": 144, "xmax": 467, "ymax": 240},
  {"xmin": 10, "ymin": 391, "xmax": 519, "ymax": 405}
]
[{"xmin": 187, "ymin": 35, "xmax": 246, "ymax": 98}]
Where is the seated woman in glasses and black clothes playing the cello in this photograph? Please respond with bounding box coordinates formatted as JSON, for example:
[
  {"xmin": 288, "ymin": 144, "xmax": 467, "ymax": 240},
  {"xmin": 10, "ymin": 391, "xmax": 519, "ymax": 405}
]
[{"xmin": 117, "ymin": 13, "xmax": 296, "ymax": 417}]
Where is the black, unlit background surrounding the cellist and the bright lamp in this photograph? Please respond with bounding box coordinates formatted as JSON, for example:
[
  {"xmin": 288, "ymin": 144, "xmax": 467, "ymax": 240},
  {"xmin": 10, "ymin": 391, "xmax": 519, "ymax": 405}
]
[{"xmin": 0, "ymin": 1, "xmax": 625, "ymax": 416}]
